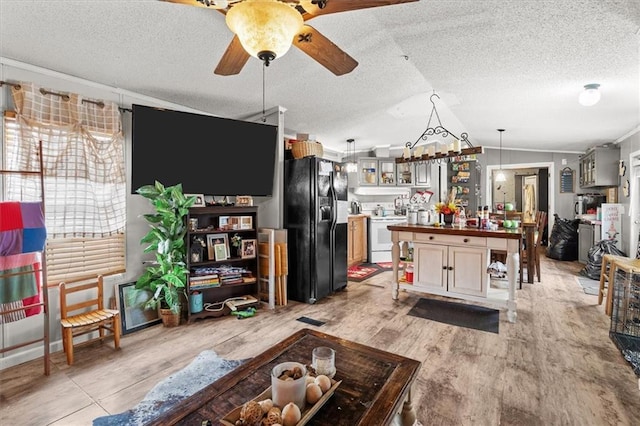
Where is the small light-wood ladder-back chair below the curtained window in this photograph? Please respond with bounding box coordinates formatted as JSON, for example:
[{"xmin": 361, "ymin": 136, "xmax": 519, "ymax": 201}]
[{"xmin": 58, "ymin": 275, "xmax": 122, "ymax": 365}]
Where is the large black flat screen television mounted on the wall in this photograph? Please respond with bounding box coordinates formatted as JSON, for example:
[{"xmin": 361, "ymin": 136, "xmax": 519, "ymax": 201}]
[{"xmin": 131, "ymin": 104, "xmax": 278, "ymax": 196}]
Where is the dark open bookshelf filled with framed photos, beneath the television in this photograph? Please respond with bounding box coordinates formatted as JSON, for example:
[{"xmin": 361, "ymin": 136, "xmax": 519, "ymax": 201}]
[{"xmin": 185, "ymin": 206, "xmax": 259, "ymax": 322}]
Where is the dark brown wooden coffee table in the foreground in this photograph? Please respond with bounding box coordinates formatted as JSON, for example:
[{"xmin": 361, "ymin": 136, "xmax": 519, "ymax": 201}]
[{"xmin": 152, "ymin": 328, "xmax": 421, "ymax": 426}]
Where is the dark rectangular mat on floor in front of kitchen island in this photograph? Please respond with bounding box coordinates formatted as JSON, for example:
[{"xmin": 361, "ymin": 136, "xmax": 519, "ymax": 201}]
[{"xmin": 408, "ymin": 298, "xmax": 500, "ymax": 334}]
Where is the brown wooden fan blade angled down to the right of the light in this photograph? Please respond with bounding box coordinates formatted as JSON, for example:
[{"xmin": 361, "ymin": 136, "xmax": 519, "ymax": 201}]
[{"xmin": 293, "ymin": 25, "xmax": 358, "ymax": 75}]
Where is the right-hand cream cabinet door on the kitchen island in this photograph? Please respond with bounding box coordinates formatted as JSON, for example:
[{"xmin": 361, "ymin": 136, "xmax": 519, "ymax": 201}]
[{"xmin": 448, "ymin": 247, "xmax": 488, "ymax": 297}]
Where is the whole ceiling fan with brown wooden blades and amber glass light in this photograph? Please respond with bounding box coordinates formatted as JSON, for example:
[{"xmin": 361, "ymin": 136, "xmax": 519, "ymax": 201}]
[{"xmin": 161, "ymin": 0, "xmax": 419, "ymax": 75}]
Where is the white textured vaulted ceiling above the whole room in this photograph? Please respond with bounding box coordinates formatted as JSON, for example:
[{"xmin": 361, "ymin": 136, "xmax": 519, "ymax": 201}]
[{"xmin": 0, "ymin": 0, "xmax": 640, "ymax": 154}]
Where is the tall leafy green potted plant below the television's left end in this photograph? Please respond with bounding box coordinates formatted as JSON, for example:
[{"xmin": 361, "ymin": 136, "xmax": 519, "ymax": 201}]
[{"xmin": 136, "ymin": 181, "xmax": 196, "ymax": 326}]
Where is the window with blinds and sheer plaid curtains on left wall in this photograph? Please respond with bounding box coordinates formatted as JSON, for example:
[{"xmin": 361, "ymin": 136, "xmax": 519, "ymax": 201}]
[{"xmin": 2, "ymin": 84, "xmax": 126, "ymax": 286}]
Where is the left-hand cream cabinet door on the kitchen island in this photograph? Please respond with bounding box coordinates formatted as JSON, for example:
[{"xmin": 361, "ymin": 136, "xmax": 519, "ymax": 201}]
[{"xmin": 413, "ymin": 243, "xmax": 449, "ymax": 291}]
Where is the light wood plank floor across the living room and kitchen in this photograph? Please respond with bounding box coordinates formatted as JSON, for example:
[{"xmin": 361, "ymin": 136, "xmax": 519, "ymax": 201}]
[{"xmin": 0, "ymin": 251, "xmax": 640, "ymax": 426}]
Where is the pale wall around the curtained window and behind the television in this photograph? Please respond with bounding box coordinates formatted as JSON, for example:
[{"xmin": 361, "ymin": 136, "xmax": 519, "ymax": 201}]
[{"xmin": 0, "ymin": 58, "xmax": 285, "ymax": 369}]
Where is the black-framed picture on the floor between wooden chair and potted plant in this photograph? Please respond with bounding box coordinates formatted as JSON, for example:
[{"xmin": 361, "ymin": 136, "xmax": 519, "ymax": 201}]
[{"xmin": 116, "ymin": 282, "xmax": 162, "ymax": 334}]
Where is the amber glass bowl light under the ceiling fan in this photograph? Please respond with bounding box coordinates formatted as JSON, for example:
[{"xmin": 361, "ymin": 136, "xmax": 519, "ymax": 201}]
[{"xmin": 226, "ymin": 0, "xmax": 304, "ymax": 65}]
